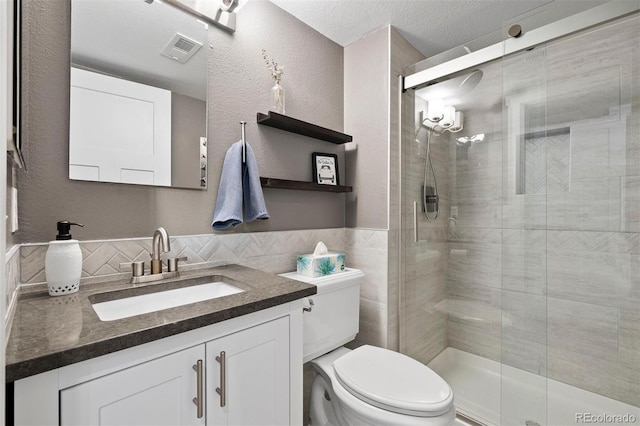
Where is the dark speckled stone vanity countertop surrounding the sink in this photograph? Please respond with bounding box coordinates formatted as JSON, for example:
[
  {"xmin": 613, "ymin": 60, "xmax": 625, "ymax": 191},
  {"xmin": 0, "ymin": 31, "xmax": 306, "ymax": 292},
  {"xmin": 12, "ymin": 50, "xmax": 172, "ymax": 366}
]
[{"xmin": 6, "ymin": 265, "xmax": 316, "ymax": 382}]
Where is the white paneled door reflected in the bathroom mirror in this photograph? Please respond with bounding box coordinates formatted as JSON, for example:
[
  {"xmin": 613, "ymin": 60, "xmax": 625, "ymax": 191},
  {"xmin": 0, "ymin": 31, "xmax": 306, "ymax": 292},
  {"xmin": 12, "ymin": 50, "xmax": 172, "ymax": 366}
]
[{"xmin": 69, "ymin": 68, "xmax": 171, "ymax": 186}]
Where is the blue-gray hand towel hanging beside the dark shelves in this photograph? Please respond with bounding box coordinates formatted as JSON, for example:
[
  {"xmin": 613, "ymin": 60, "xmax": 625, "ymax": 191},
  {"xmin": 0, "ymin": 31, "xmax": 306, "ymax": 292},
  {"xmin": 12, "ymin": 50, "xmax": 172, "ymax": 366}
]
[{"xmin": 211, "ymin": 141, "xmax": 269, "ymax": 230}]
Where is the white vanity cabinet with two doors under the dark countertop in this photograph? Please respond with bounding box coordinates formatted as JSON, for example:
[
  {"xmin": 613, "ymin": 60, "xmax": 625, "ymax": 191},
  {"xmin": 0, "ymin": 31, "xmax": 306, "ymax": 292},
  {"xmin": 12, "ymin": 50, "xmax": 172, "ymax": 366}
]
[{"xmin": 15, "ymin": 300, "xmax": 302, "ymax": 426}]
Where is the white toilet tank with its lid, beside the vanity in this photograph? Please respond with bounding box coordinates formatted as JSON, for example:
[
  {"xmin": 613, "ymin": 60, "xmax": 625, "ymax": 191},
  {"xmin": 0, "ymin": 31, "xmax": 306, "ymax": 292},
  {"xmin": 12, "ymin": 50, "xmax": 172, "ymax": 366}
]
[{"xmin": 280, "ymin": 268, "xmax": 364, "ymax": 362}]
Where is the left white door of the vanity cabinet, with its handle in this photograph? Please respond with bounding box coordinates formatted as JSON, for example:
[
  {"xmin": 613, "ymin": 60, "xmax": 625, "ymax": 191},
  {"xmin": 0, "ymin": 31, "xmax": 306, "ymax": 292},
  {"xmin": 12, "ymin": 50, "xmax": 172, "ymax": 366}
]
[{"xmin": 60, "ymin": 345, "xmax": 205, "ymax": 426}]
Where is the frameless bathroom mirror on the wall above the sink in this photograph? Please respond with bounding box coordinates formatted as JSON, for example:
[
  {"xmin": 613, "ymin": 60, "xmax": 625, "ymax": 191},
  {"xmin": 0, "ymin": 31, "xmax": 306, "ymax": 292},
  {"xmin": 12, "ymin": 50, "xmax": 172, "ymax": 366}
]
[{"xmin": 69, "ymin": 0, "xmax": 208, "ymax": 189}]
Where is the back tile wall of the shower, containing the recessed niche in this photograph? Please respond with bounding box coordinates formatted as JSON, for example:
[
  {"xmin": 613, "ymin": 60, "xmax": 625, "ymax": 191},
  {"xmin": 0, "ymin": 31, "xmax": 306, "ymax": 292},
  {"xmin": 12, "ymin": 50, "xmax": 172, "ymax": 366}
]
[{"xmin": 444, "ymin": 16, "xmax": 640, "ymax": 406}]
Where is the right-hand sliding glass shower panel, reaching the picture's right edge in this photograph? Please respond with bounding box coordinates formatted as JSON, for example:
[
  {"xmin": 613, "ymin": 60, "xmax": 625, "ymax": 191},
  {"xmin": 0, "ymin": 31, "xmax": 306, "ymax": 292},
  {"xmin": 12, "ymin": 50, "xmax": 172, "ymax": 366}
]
[{"xmin": 500, "ymin": 7, "xmax": 640, "ymax": 425}]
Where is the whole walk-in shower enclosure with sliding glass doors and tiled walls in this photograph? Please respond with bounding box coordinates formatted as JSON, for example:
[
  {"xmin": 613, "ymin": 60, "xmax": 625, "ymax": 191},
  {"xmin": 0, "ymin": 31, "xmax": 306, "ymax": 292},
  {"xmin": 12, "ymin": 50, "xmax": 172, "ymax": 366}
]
[{"xmin": 399, "ymin": 1, "xmax": 640, "ymax": 426}]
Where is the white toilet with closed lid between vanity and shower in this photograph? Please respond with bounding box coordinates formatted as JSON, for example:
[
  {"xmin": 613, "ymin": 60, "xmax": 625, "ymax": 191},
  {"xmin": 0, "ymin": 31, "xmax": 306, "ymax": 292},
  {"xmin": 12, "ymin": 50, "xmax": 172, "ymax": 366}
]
[{"xmin": 281, "ymin": 268, "xmax": 456, "ymax": 426}]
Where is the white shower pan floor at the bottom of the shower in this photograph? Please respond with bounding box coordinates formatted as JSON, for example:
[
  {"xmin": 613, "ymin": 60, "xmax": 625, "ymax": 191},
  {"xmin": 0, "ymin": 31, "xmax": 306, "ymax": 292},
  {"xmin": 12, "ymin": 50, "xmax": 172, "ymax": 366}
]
[{"xmin": 428, "ymin": 347, "xmax": 640, "ymax": 426}]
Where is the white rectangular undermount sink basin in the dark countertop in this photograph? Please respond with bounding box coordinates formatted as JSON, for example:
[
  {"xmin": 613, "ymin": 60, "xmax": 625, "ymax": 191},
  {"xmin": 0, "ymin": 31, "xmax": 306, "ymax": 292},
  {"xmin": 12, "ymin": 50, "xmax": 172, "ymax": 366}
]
[{"xmin": 93, "ymin": 281, "xmax": 244, "ymax": 321}]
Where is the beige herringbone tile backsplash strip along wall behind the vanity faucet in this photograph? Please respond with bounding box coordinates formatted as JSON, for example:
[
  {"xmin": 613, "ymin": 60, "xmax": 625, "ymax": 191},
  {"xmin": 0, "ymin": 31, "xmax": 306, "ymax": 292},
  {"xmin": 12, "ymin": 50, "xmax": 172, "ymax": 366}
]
[{"xmin": 20, "ymin": 228, "xmax": 349, "ymax": 284}]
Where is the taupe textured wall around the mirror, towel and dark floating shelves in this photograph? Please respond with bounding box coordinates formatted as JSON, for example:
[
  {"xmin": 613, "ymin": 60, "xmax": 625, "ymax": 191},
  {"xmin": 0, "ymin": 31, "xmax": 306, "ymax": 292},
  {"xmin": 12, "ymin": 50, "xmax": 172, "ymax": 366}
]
[{"xmin": 18, "ymin": 0, "xmax": 345, "ymax": 243}]
